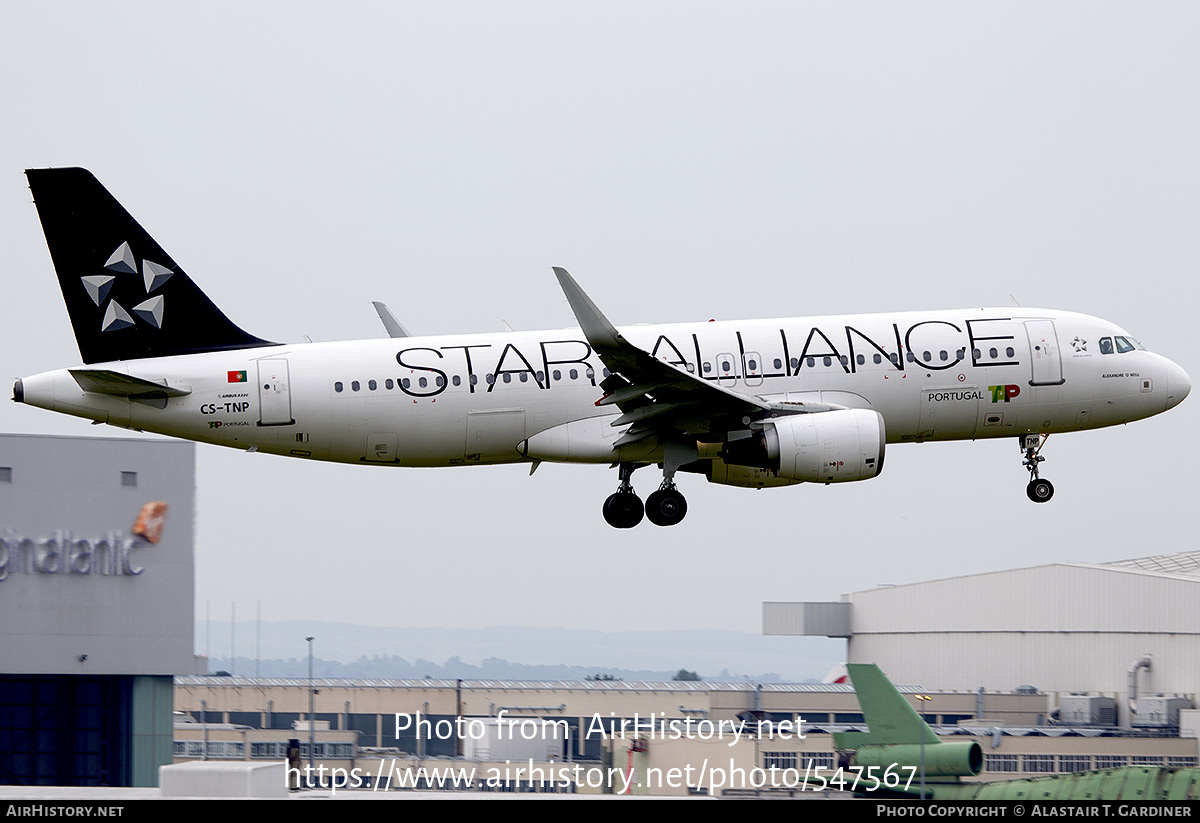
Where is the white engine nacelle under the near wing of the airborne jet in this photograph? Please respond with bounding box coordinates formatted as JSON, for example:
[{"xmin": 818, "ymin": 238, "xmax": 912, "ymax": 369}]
[{"xmin": 721, "ymin": 409, "xmax": 886, "ymax": 483}]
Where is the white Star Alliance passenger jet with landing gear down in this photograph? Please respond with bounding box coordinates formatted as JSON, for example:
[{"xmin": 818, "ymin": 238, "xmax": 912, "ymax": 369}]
[{"xmin": 13, "ymin": 169, "xmax": 1192, "ymax": 528}]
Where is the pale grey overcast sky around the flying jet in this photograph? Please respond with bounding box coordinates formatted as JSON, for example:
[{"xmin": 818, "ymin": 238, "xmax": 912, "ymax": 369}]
[{"xmin": 0, "ymin": 0, "xmax": 1200, "ymax": 662}]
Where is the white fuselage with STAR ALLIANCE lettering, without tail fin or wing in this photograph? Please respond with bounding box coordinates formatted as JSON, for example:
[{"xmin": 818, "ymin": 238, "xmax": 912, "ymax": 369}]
[{"xmin": 22, "ymin": 308, "xmax": 1190, "ymax": 467}]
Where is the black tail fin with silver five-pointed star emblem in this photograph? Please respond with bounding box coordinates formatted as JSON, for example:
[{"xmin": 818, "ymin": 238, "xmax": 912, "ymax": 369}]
[{"xmin": 25, "ymin": 169, "xmax": 271, "ymax": 364}]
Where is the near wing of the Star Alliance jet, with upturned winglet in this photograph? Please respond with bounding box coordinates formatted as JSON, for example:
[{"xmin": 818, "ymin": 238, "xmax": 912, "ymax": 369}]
[{"xmin": 554, "ymin": 266, "xmax": 839, "ymax": 446}]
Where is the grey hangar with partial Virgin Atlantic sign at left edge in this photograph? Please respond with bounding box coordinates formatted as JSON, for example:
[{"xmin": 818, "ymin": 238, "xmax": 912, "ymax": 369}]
[{"xmin": 0, "ymin": 434, "xmax": 196, "ymax": 786}]
